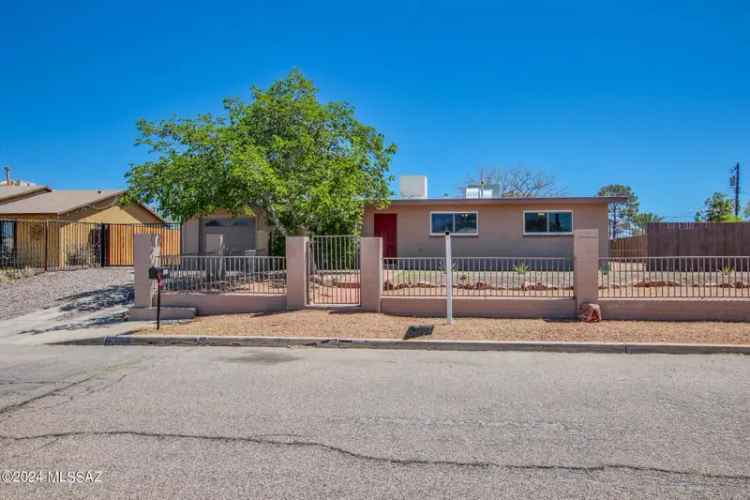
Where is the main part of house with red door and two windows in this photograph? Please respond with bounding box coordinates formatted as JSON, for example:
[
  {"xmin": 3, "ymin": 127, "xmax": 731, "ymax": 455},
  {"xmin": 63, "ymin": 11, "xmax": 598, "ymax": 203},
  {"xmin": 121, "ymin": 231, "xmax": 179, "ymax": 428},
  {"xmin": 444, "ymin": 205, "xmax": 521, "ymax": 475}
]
[{"xmin": 362, "ymin": 197, "xmax": 622, "ymax": 257}]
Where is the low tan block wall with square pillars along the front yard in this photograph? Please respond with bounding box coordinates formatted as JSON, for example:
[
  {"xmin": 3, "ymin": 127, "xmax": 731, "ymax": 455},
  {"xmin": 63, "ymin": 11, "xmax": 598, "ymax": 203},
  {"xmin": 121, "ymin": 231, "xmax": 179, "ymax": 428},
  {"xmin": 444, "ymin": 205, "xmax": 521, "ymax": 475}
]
[{"xmin": 134, "ymin": 229, "xmax": 750, "ymax": 321}]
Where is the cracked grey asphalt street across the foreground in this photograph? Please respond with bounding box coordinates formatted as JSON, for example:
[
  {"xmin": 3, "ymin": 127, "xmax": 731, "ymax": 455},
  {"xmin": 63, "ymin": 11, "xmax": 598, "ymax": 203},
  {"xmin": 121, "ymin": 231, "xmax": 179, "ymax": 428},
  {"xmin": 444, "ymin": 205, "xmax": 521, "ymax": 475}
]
[{"xmin": 0, "ymin": 344, "xmax": 750, "ymax": 499}]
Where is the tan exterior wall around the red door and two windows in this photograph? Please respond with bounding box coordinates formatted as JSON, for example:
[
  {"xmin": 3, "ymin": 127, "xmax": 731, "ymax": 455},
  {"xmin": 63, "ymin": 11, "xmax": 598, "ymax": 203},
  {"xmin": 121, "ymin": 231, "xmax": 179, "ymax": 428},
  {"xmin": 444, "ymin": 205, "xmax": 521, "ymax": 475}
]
[{"xmin": 362, "ymin": 201, "xmax": 609, "ymax": 257}]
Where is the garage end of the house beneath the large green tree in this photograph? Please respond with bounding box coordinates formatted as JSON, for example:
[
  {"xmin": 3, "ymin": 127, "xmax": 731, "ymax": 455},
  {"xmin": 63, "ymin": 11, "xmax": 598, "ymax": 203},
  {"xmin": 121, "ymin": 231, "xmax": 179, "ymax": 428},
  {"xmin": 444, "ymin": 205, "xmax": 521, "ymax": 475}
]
[{"xmin": 182, "ymin": 211, "xmax": 271, "ymax": 255}]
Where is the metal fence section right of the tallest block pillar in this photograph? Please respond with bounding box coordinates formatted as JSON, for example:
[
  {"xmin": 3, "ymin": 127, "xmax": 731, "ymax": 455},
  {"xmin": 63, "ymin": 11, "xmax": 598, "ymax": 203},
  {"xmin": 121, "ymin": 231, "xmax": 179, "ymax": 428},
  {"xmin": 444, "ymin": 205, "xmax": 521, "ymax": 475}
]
[{"xmin": 599, "ymin": 256, "xmax": 750, "ymax": 298}]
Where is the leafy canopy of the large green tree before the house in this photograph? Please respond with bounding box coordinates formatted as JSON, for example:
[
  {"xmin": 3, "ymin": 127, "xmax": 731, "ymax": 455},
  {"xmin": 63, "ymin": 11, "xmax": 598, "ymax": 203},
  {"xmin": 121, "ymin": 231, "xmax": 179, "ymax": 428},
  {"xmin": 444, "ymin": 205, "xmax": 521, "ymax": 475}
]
[{"xmin": 126, "ymin": 70, "xmax": 396, "ymax": 235}]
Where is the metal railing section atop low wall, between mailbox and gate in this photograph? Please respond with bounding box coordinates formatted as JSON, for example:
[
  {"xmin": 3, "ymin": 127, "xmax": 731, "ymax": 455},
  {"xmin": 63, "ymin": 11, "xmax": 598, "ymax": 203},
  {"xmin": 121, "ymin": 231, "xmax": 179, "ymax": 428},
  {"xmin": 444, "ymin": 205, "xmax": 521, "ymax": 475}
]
[{"xmin": 161, "ymin": 255, "xmax": 286, "ymax": 295}]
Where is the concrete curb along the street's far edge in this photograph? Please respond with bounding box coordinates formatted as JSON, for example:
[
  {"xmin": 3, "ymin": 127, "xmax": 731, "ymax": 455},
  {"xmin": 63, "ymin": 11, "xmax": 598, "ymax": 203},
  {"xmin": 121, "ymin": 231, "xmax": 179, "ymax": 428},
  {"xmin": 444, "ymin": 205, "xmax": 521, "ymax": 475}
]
[{"xmin": 56, "ymin": 335, "xmax": 750, "ymax": 354}]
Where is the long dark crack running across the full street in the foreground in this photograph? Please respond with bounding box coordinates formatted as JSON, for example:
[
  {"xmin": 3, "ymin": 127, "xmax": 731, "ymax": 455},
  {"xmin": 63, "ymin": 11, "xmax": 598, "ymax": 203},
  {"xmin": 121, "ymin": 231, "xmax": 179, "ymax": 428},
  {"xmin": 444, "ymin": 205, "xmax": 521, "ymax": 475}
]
[{"xmin": 0, "ymin": 430, "xmax": 750, "ymax": 482}]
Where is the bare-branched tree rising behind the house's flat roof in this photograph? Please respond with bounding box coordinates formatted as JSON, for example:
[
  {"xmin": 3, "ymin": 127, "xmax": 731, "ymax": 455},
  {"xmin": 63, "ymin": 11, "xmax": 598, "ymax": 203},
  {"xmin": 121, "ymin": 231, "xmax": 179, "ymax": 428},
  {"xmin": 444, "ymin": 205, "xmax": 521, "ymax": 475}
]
[{"xmin": 458, "ymin": 167, "xmax": 561, "ymax": 198}]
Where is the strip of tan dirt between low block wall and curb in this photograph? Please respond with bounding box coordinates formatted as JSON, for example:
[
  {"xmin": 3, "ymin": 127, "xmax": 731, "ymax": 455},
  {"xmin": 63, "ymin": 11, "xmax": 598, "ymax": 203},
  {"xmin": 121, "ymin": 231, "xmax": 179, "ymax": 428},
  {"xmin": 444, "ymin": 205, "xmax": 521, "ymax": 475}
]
[{"xmin": 138, "ymin": 310, "xmax": 750, "ymax": 344}]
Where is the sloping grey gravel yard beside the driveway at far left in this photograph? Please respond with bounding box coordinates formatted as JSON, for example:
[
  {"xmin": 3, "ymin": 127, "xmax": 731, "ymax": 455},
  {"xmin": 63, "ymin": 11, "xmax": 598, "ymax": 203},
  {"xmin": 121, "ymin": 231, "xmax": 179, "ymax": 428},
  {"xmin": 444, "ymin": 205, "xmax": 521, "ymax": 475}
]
[{"xmin": 0, "ymin": 267, "xmax": 133, "ymax": 319}]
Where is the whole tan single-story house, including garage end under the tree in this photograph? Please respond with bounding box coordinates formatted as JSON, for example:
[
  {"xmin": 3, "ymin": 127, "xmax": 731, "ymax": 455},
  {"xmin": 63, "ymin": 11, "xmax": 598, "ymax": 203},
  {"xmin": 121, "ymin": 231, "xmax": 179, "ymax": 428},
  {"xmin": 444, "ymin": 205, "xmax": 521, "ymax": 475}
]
[{"xmin": 182, "ymin": 197, "xmax": 622, "ymax": 257}]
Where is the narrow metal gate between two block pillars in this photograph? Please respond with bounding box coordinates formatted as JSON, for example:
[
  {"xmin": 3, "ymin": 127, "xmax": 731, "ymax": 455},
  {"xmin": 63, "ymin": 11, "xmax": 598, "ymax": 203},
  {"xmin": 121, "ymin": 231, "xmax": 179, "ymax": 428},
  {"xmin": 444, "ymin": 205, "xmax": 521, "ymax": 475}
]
[{"xmin": 307, "ymin": 236, "xmax": 360, "ymax": 305}]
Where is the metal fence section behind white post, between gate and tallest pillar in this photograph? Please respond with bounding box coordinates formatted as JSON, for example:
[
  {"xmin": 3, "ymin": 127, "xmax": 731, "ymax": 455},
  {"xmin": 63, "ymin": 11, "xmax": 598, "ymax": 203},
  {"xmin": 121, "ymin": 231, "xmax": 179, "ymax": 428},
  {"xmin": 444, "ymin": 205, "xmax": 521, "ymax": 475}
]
[{"xmin": 383, "ymin": 257, "xmax": 573, "ymax": 297}]
